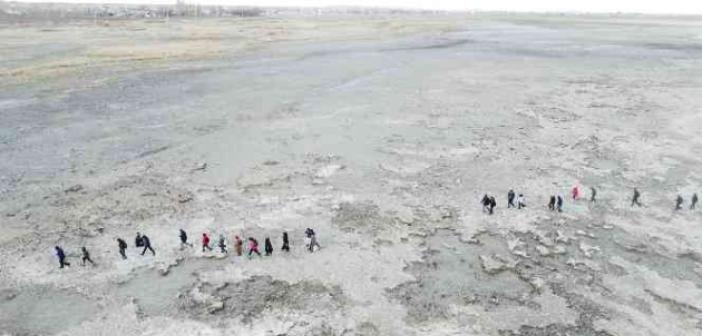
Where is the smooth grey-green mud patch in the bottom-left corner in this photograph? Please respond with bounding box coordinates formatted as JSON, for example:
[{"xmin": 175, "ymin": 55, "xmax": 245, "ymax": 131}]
[{"xmin": 0, "ymin": 286, "xmax": 99, "ymax": 335}]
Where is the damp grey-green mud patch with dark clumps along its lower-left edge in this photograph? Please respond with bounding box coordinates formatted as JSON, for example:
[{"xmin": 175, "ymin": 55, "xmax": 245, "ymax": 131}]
[{"xmin": 387, "ymin": 229, "xmax": 533, "ymax": 323}]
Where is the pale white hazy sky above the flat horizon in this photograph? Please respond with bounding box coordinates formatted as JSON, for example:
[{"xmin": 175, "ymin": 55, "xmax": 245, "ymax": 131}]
[{"xmin": 12, "ymin": 0, "xmax": 702, "ymax": 14}]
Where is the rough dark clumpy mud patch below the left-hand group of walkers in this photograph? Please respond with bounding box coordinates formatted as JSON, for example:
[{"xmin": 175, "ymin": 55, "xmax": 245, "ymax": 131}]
[{"xmin": 179, "ymin": 276, "xmax": 348, "ymax": 323}]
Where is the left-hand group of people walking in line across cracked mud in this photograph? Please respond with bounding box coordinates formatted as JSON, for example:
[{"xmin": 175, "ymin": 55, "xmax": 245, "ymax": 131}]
[{"xmin": 54, "ymin": 228, "xmax": 320, "ymax": 268}]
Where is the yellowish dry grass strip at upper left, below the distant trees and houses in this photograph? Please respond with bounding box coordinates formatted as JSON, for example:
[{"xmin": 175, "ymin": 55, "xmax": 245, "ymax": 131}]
[{"xmin": 0, "ymin": 17, "xmax": 457, "ymax": 86}]
